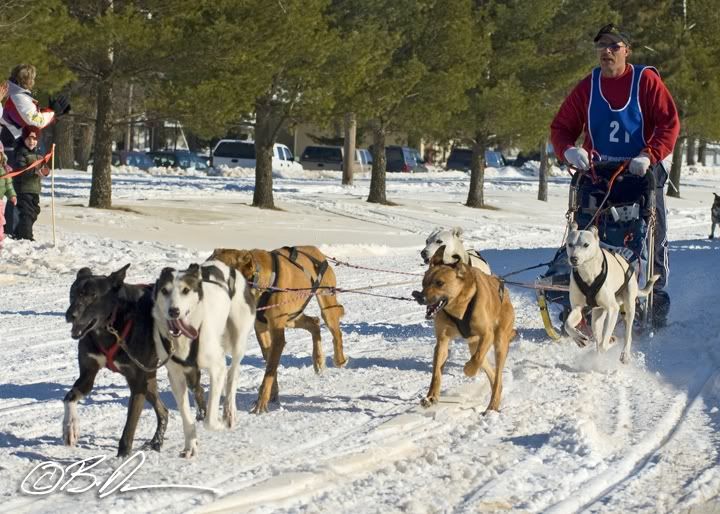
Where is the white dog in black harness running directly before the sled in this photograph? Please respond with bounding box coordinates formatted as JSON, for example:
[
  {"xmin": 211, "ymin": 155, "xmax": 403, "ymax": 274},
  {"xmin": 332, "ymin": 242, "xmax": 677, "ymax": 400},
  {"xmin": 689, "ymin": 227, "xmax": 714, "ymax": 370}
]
[{"xmin": 565, "ymin": 223, "xmax": 660, "ymax": 364}]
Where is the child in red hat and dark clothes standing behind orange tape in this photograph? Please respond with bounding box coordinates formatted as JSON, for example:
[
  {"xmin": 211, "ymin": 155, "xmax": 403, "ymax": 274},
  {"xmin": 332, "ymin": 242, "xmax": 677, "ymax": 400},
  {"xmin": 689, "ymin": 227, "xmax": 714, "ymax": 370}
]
[{"xmin": 8, "ymin": 126, "xmax": 50, "ymax": 241}]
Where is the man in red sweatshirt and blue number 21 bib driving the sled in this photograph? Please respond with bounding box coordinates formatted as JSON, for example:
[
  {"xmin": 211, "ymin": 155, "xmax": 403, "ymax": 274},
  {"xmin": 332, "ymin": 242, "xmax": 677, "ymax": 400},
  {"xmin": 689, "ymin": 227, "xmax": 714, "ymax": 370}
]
[{"xmin": 550, "ymin": 24, "xmax": 680, "ymax": 327}]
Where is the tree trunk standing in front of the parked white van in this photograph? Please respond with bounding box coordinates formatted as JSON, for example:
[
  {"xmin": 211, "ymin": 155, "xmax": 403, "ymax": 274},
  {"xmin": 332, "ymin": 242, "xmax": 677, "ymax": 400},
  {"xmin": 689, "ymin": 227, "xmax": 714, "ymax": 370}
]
[{"xmin": 252, "ymin": 98, "xmax": 275, "ymax": 209}]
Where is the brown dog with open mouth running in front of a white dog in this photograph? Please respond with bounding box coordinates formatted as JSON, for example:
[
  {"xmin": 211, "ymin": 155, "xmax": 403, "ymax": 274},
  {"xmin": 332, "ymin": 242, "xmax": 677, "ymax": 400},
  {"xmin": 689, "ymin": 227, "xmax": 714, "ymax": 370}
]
[{"xmin": 413, "ymin": 247, "xmax": 515, "ymax": 412}]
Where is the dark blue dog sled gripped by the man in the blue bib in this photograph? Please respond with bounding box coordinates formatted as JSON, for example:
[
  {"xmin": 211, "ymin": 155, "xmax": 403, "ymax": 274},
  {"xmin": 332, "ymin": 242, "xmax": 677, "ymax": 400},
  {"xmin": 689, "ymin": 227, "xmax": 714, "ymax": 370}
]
[{"xmin": 535, "ymin": 162, "xmax": 655, "ymax": 341}]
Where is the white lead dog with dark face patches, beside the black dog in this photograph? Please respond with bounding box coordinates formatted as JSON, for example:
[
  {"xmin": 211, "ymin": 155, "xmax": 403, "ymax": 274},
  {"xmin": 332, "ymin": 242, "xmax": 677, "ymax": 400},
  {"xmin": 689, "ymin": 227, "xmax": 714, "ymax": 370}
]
[{"xmin": 153, "ymin": 261, "xmax": 255, "ymax": 457}]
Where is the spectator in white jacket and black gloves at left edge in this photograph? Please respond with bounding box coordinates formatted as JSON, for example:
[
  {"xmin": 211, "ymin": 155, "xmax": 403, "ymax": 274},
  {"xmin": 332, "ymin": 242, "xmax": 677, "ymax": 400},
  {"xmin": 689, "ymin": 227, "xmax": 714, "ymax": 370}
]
[{"xmin": 0, "ymin": 64, "xmax": 70, "ymax": 147}]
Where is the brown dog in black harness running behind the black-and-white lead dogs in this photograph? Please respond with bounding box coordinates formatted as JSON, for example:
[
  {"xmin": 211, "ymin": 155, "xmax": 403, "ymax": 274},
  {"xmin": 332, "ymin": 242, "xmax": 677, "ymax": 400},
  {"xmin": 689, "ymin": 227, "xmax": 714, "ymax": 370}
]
[{"xmin": 210, "ymin": 246, "xmax": 347, "ymax": 414}]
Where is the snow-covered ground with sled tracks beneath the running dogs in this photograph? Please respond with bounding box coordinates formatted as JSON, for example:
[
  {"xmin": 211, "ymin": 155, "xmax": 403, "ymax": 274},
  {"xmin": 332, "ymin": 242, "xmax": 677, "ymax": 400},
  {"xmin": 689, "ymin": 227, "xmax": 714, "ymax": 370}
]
[{"xmin": 0, "ymin": 163, "xmax": 720, "ymax": 513}]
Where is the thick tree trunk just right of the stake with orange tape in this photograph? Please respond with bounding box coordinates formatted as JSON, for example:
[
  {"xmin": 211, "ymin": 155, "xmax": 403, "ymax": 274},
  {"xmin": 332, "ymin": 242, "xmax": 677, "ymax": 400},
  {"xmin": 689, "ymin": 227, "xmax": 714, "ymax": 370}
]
[{"xmin": 88, "ymin": 79, "xmax": 113, "ymax": 209}]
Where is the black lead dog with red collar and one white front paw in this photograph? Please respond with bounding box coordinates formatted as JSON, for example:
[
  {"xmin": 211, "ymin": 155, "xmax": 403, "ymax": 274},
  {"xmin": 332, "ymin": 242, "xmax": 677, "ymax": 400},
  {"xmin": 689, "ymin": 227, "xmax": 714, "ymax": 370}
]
[{"xmin": 63, "ymin": 264, "xmax": 205, "ymax": 457}]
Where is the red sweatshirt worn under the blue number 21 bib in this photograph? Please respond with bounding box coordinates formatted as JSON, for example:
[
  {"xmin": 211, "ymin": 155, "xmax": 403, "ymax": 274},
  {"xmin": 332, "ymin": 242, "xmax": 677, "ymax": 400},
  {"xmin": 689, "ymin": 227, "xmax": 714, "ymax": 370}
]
[{"xmin": 550, "ymin": 65, "xmax": 680, "ymax": 164}]
